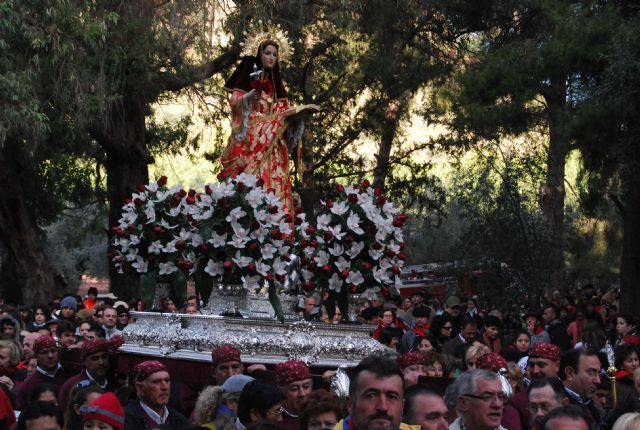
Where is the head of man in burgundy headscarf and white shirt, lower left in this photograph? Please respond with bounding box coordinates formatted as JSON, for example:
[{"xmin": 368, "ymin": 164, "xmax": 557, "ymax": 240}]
[{"xmin": 133, "ymin": 360, "xmax": 171, "ymax": 415}]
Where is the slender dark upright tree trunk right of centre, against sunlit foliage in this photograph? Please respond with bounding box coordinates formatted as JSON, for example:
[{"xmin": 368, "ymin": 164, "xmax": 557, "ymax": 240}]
[{"xmin": 540, "ymin": 78, "xmax": 569, "ymax": 290}]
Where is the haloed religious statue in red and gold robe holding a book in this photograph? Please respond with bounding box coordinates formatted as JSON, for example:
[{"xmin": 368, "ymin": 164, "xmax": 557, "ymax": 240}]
[{"xmin": 221, "ymin": 26, "xmax": 317, "ymax": 213}]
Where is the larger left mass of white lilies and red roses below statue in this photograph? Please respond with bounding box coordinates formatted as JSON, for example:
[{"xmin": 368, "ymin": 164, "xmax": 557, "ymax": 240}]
[{"xmin": 111, "ymin": 174, "xmax": 293, "ymax": 320}]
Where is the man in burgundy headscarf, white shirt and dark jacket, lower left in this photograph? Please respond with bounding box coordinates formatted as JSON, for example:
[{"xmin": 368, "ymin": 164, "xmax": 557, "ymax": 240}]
[{"xmin": 124, "ymin": 360, "xmax": 189, "ymax": 430}]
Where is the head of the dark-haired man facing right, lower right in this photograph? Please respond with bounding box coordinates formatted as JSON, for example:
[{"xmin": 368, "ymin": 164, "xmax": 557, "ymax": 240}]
[{"xmin": 560, "ymin": 349, "xmax": 602, "ymax": 400}]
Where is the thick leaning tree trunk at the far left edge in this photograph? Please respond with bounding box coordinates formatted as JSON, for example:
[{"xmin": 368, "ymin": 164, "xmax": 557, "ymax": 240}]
[{"xmin": 0, "ymin": 153, "xmax": 64, "ymax": 304}]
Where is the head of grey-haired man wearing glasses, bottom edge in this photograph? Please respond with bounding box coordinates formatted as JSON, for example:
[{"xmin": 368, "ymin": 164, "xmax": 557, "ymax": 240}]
[{"xmin": 455, "ymin": 369, "xmax": 506, "ymax": 430}]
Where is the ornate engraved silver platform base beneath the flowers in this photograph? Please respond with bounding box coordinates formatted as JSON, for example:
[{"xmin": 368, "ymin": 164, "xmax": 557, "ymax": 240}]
[{"xmin": 120, "ymin": 310, "xmax": 384, "ymax": 367}]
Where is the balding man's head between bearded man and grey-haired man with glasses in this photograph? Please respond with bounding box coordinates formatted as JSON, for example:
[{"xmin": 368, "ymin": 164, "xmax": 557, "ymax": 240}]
[{"xmin": 403, "ymin": 385, "xmax": 449, "ymax": 430}]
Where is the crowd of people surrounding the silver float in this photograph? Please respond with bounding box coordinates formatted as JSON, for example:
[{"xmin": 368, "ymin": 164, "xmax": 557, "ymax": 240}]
[{"xmin": 0, "ymin": 287, "xmax": 640, "ymax": 430}]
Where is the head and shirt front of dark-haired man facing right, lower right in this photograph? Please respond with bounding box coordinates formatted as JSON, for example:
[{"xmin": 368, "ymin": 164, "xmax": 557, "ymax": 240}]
[{"xmin": 560, "ymin": 349, "xmax": 604, "ymax": 430}]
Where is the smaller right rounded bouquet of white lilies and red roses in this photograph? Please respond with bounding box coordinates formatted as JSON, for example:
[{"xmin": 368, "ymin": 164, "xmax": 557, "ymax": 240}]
[{"xmin": 297, "ymin": 180, "xmax": 407, "ymax": 314}]
